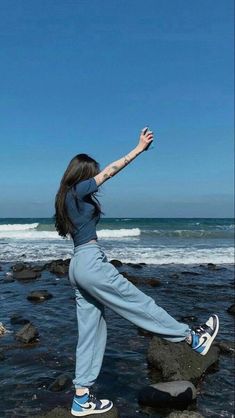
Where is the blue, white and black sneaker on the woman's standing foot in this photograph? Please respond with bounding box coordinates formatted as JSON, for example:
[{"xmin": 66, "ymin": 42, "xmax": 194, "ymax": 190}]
[{"xmin": 71, "ymin": 389, "xmax": 113, "ymax": 417}]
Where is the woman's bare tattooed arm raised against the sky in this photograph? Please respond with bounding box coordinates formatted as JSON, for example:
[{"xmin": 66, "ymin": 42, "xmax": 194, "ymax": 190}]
[{"xmin": 94, "ymin": 128, "xmax": 153, "ymax": 186}]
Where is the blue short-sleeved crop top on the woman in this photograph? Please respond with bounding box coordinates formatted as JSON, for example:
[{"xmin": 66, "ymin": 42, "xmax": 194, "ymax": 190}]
[{"xmin": 65, "ymin": 177, "xmax": 100, "ymax": 247}]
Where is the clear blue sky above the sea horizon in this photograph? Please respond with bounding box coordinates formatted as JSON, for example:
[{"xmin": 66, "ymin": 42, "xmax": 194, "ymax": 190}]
[{"xmin": 0, "ymin": 0, "xmax": 234, "ymax": 217}]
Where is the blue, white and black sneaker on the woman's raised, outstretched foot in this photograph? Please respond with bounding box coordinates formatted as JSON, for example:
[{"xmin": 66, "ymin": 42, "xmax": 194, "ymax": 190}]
[{"xmin": 190, "ymin": 314, "xmax": 219, "ymax": 356}]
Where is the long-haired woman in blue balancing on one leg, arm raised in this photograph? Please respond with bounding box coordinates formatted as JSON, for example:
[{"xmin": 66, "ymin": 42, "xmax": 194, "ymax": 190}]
[{"xmin": 55, "ymin": 128, "xmax": 219, "ymax": 416}]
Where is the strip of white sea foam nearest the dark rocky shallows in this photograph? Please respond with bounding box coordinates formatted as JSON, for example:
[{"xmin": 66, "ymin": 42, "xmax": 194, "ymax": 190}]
[{"xmin": 0, "ymin": 240, "xmax": 234, "ymax": 264}]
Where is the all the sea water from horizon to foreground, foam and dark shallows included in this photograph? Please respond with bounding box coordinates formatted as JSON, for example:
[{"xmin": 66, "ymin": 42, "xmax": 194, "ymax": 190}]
[{"xmin": 0, "ymin": 218, "xmax": 235, "ymax": 418}]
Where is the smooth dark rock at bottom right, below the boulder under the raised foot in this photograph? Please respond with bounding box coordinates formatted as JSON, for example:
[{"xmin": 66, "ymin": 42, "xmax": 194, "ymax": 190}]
[{"xmin": 138, "ymin": 380, "xmax": 197, "ymax": 408}]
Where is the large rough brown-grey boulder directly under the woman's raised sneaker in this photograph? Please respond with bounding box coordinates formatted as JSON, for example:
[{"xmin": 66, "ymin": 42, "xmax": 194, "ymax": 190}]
[{"xmin": 147, "ymin": 336, "xmax": 219, "ymax": 383}]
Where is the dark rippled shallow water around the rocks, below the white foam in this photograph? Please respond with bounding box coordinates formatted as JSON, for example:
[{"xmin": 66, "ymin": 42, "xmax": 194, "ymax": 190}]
[{"xmin": 0, "ymin": 263, "xmax": 234, "ymax": 418}]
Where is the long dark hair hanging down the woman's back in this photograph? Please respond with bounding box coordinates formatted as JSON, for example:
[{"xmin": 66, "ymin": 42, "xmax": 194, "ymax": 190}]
[{"xmin": 53, "ymin": 154, "xmax": 103, "ymax": 238}]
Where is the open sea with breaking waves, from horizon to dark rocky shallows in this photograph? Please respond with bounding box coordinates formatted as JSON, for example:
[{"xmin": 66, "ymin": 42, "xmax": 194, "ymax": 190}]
[{"xmin": 0, "ymin": 218, "xmax": 234, "ymax": 264}]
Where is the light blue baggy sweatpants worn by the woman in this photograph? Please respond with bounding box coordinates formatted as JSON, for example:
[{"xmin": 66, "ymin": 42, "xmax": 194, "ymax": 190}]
[{"xmin": 69, "ymin": 242, "xmax": 190, "ymax": 388}]
